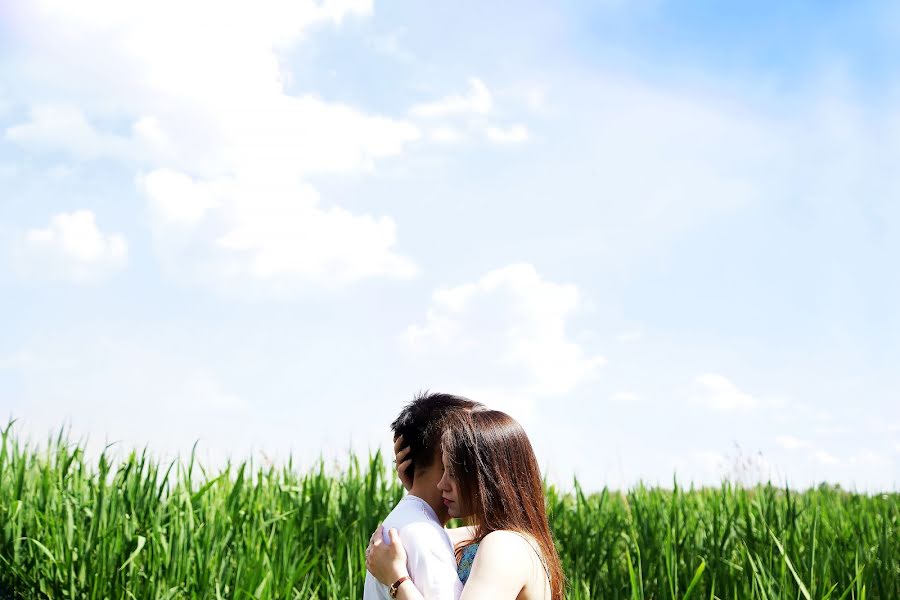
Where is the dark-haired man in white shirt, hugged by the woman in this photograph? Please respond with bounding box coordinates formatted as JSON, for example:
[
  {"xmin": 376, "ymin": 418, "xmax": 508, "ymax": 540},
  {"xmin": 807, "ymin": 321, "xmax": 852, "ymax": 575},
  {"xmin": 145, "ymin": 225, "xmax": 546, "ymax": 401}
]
[{"xmin": 363, "ymin": 393, "xmax": 482, "ymax": 600}]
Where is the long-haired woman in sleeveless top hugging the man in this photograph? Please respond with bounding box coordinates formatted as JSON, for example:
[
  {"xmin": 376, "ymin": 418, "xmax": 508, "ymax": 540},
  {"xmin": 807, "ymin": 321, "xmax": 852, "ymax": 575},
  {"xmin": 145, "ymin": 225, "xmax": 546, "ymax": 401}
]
[{"xmin": 366, "ymin": 410, "xmax": 565, "ymax": 600}]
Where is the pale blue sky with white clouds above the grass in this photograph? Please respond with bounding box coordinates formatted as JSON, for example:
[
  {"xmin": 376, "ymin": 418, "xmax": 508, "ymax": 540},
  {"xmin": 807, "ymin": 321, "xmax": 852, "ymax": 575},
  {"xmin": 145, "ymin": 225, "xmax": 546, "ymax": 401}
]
[{"xmin": 0, "ymin": 0, "xmax": 900, "ymax": 492}]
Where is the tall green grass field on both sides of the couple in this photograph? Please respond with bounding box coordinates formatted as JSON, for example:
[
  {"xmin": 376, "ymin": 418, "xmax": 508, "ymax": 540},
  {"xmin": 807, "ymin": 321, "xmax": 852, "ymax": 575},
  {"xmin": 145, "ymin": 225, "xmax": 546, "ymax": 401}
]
[{"xmin": 0, "ymin": 424, "xmax": 900, "ymax": 600}]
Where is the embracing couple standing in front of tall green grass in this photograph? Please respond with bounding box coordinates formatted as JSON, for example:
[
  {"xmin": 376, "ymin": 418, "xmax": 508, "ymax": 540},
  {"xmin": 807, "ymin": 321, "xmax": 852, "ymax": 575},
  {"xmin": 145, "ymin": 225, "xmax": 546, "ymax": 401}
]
[{"xmin": 363, "ymin": 394, "xmax": 565, "ymax": 600}]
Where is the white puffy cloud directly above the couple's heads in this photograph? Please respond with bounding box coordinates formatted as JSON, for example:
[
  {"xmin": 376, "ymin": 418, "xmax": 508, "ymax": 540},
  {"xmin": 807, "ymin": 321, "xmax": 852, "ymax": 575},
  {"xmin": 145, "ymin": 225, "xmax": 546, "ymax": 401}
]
[{"xmin": 404, "ymin": 264, "xmax": 606, "ymax": 420}]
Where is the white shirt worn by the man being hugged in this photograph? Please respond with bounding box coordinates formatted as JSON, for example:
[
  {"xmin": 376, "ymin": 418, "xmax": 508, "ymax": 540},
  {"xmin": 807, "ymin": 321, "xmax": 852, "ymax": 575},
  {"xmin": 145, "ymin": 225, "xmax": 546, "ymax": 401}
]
[{"xmin": 363, "ymin": 495, "xmax": 463, "ymax": 600}]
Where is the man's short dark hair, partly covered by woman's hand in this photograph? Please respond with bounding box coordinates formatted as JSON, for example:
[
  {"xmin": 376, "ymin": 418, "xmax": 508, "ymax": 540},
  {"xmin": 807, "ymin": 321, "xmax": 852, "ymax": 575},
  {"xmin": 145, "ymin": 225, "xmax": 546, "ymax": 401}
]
[{"xmin": 391, "ymin": 390, "xmax": 484, "ymax": 482}]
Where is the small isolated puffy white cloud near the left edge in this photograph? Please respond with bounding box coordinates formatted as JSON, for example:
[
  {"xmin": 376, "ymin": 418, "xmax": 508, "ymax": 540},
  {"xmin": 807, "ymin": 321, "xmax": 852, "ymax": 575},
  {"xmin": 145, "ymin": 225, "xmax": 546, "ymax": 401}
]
[{"xmin": 21, "ymin": 210, "xmax": 128, "ymax": 282}]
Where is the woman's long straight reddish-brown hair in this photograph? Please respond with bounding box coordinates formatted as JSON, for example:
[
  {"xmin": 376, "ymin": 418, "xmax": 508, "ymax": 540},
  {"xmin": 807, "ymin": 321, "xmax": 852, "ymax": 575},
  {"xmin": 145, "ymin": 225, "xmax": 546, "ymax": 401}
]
[{"xmin": 442, "ymin": 409, "xmax": 565, "ymax": 600}]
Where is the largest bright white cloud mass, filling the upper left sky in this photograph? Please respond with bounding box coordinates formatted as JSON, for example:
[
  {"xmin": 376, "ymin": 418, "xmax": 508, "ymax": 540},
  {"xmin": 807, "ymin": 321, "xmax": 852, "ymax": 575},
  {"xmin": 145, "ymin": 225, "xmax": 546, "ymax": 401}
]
[{"xmin": 6, "ymin": 0, "xmax": 421, "ymax": 289}]
